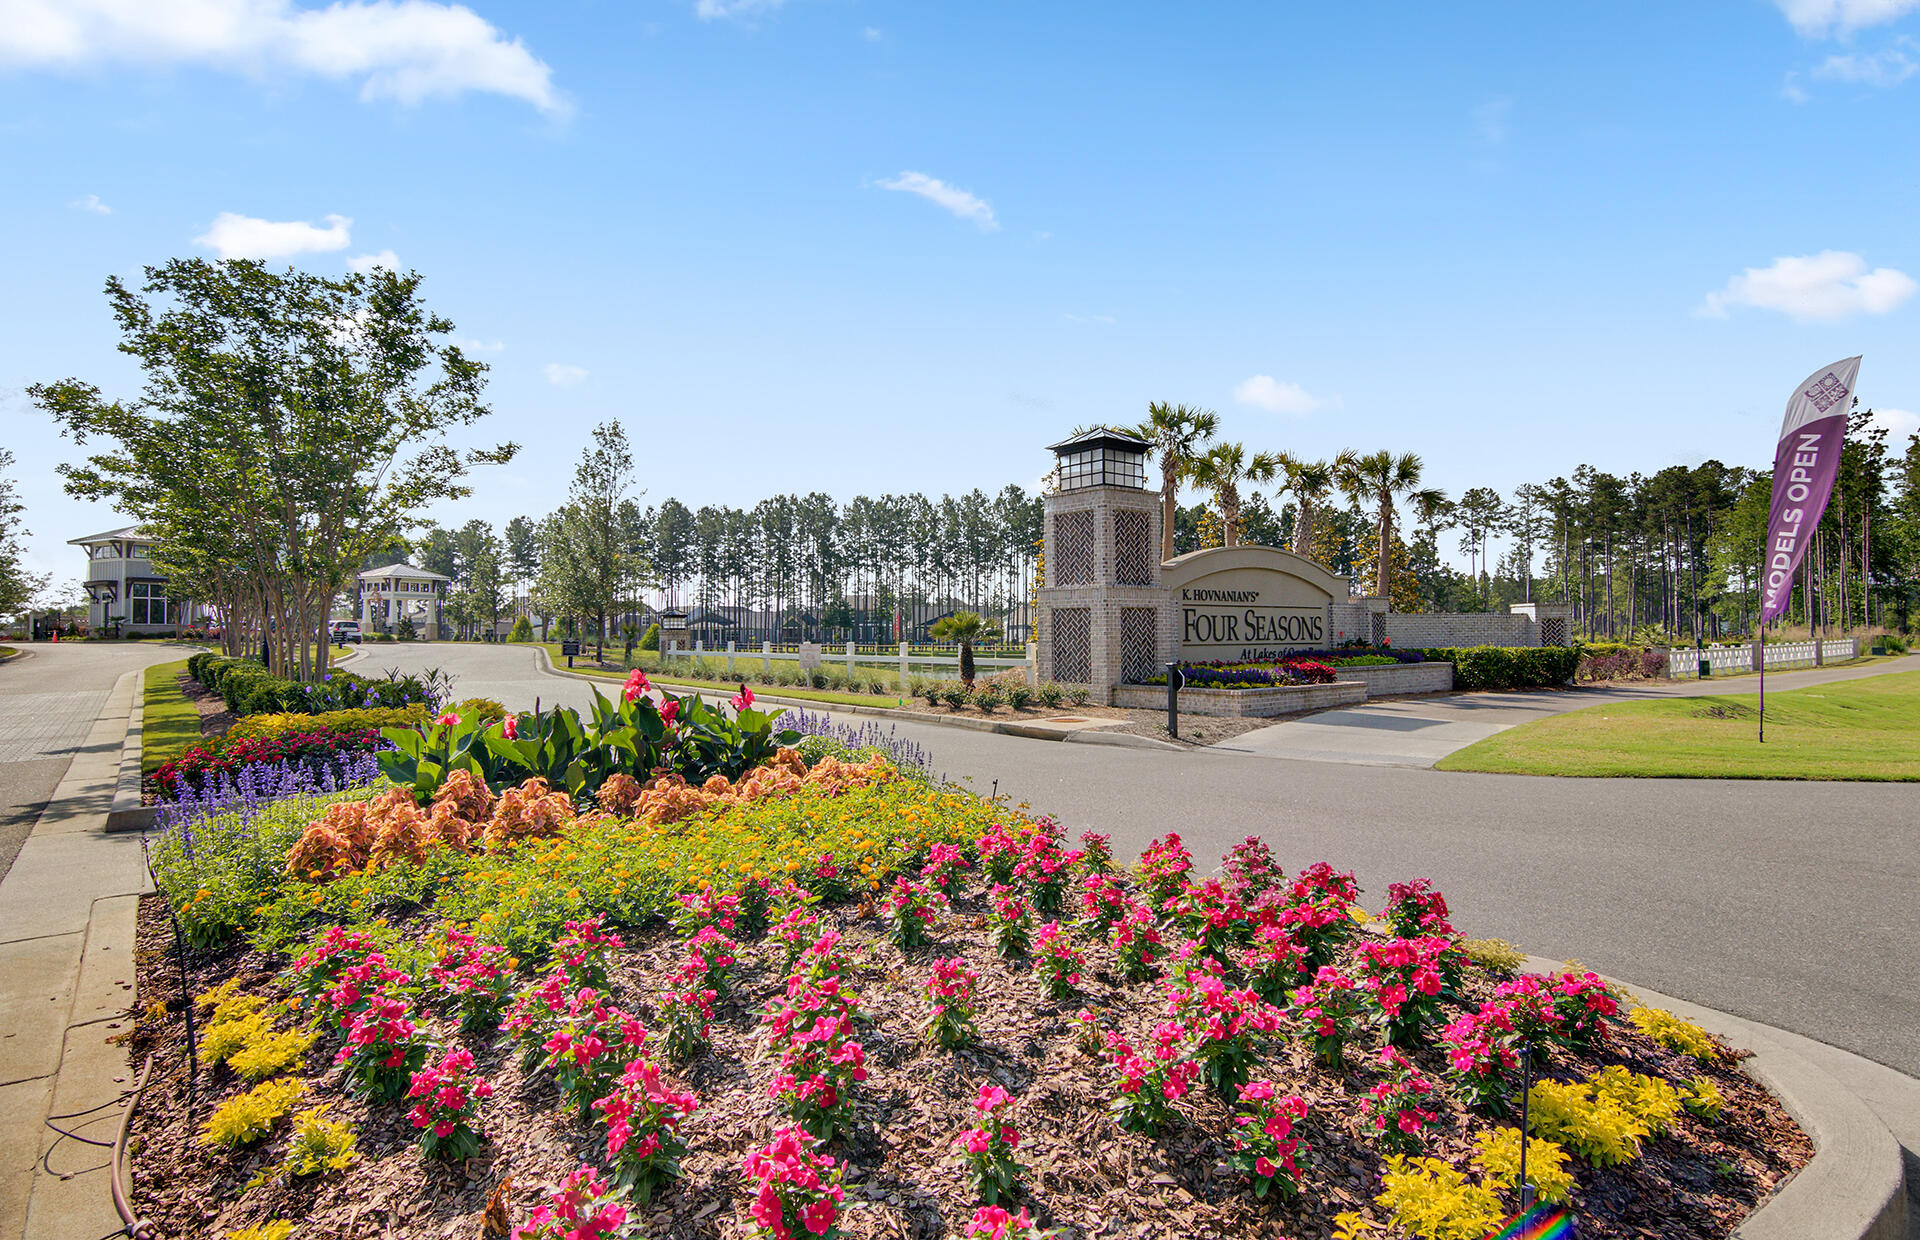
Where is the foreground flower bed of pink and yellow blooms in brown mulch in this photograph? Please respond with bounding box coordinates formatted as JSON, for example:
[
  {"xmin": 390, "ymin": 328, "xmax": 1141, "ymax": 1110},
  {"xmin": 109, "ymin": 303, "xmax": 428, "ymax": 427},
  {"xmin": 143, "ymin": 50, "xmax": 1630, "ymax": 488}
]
[{"xmin": 132, "ymin": 802, "xmax": 1811, "ymax": 1240}]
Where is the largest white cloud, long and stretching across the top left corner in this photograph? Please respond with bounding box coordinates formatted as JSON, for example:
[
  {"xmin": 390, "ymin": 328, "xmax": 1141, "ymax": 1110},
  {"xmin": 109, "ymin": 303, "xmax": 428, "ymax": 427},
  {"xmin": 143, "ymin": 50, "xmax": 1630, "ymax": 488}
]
[{"xmin": 0, "ymin": 0, "xmax": 566, "ymax": 113}]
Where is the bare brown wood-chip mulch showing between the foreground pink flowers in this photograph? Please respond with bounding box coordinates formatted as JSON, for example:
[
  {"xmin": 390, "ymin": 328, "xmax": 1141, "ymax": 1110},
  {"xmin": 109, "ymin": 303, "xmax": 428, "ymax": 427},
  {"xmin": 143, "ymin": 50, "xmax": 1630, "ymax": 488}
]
[{"xmin": 131, "ymin": 896, "xmax": 1812, "ymax": 1240}]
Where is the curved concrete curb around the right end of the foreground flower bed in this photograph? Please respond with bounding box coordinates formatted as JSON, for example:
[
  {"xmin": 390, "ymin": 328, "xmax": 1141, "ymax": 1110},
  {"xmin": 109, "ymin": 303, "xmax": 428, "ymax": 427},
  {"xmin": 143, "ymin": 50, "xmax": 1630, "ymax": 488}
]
[{"xmin": 1526, "ymin": 956, "xmax": 1908, "ymax": 1240}]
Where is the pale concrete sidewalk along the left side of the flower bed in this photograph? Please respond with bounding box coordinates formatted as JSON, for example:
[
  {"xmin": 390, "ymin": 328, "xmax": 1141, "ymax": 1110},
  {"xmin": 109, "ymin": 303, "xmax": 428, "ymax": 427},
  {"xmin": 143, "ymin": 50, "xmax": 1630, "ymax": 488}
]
[{"xmin": 0, "ymin": 672, "xmax": 148, "ymax": 1240}]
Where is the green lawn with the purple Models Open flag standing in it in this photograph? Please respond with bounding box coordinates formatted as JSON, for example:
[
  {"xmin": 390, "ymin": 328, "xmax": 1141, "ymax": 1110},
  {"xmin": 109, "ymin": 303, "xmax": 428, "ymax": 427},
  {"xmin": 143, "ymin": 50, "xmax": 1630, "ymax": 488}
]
[{"xmin": 1438, "ymin": 672, "xmax": 1920, "ymax": 779}]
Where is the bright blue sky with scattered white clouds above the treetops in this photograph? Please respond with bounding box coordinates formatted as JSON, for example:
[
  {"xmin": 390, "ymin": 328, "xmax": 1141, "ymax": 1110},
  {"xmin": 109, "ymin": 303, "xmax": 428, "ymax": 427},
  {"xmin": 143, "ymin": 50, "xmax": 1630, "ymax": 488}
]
[{"xmin": 0, "ymin": 0, "xmax": 1920, "ymax": 580}]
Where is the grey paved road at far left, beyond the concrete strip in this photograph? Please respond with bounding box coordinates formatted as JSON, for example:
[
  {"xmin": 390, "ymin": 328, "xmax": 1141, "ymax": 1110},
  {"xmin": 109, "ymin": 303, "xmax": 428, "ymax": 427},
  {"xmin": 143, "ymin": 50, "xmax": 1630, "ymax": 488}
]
[{"xmin": 0, "ymin": 641, "xmax": 204, "ymax": 877}]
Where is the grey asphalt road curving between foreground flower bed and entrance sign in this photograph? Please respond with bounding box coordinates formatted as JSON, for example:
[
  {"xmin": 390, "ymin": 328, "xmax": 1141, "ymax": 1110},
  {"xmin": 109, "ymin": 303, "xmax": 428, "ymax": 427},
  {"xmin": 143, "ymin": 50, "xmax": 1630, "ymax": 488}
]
[{"xmin": 284, "ymin": 645, "xmax": 1920, "ymax": 1075}]
